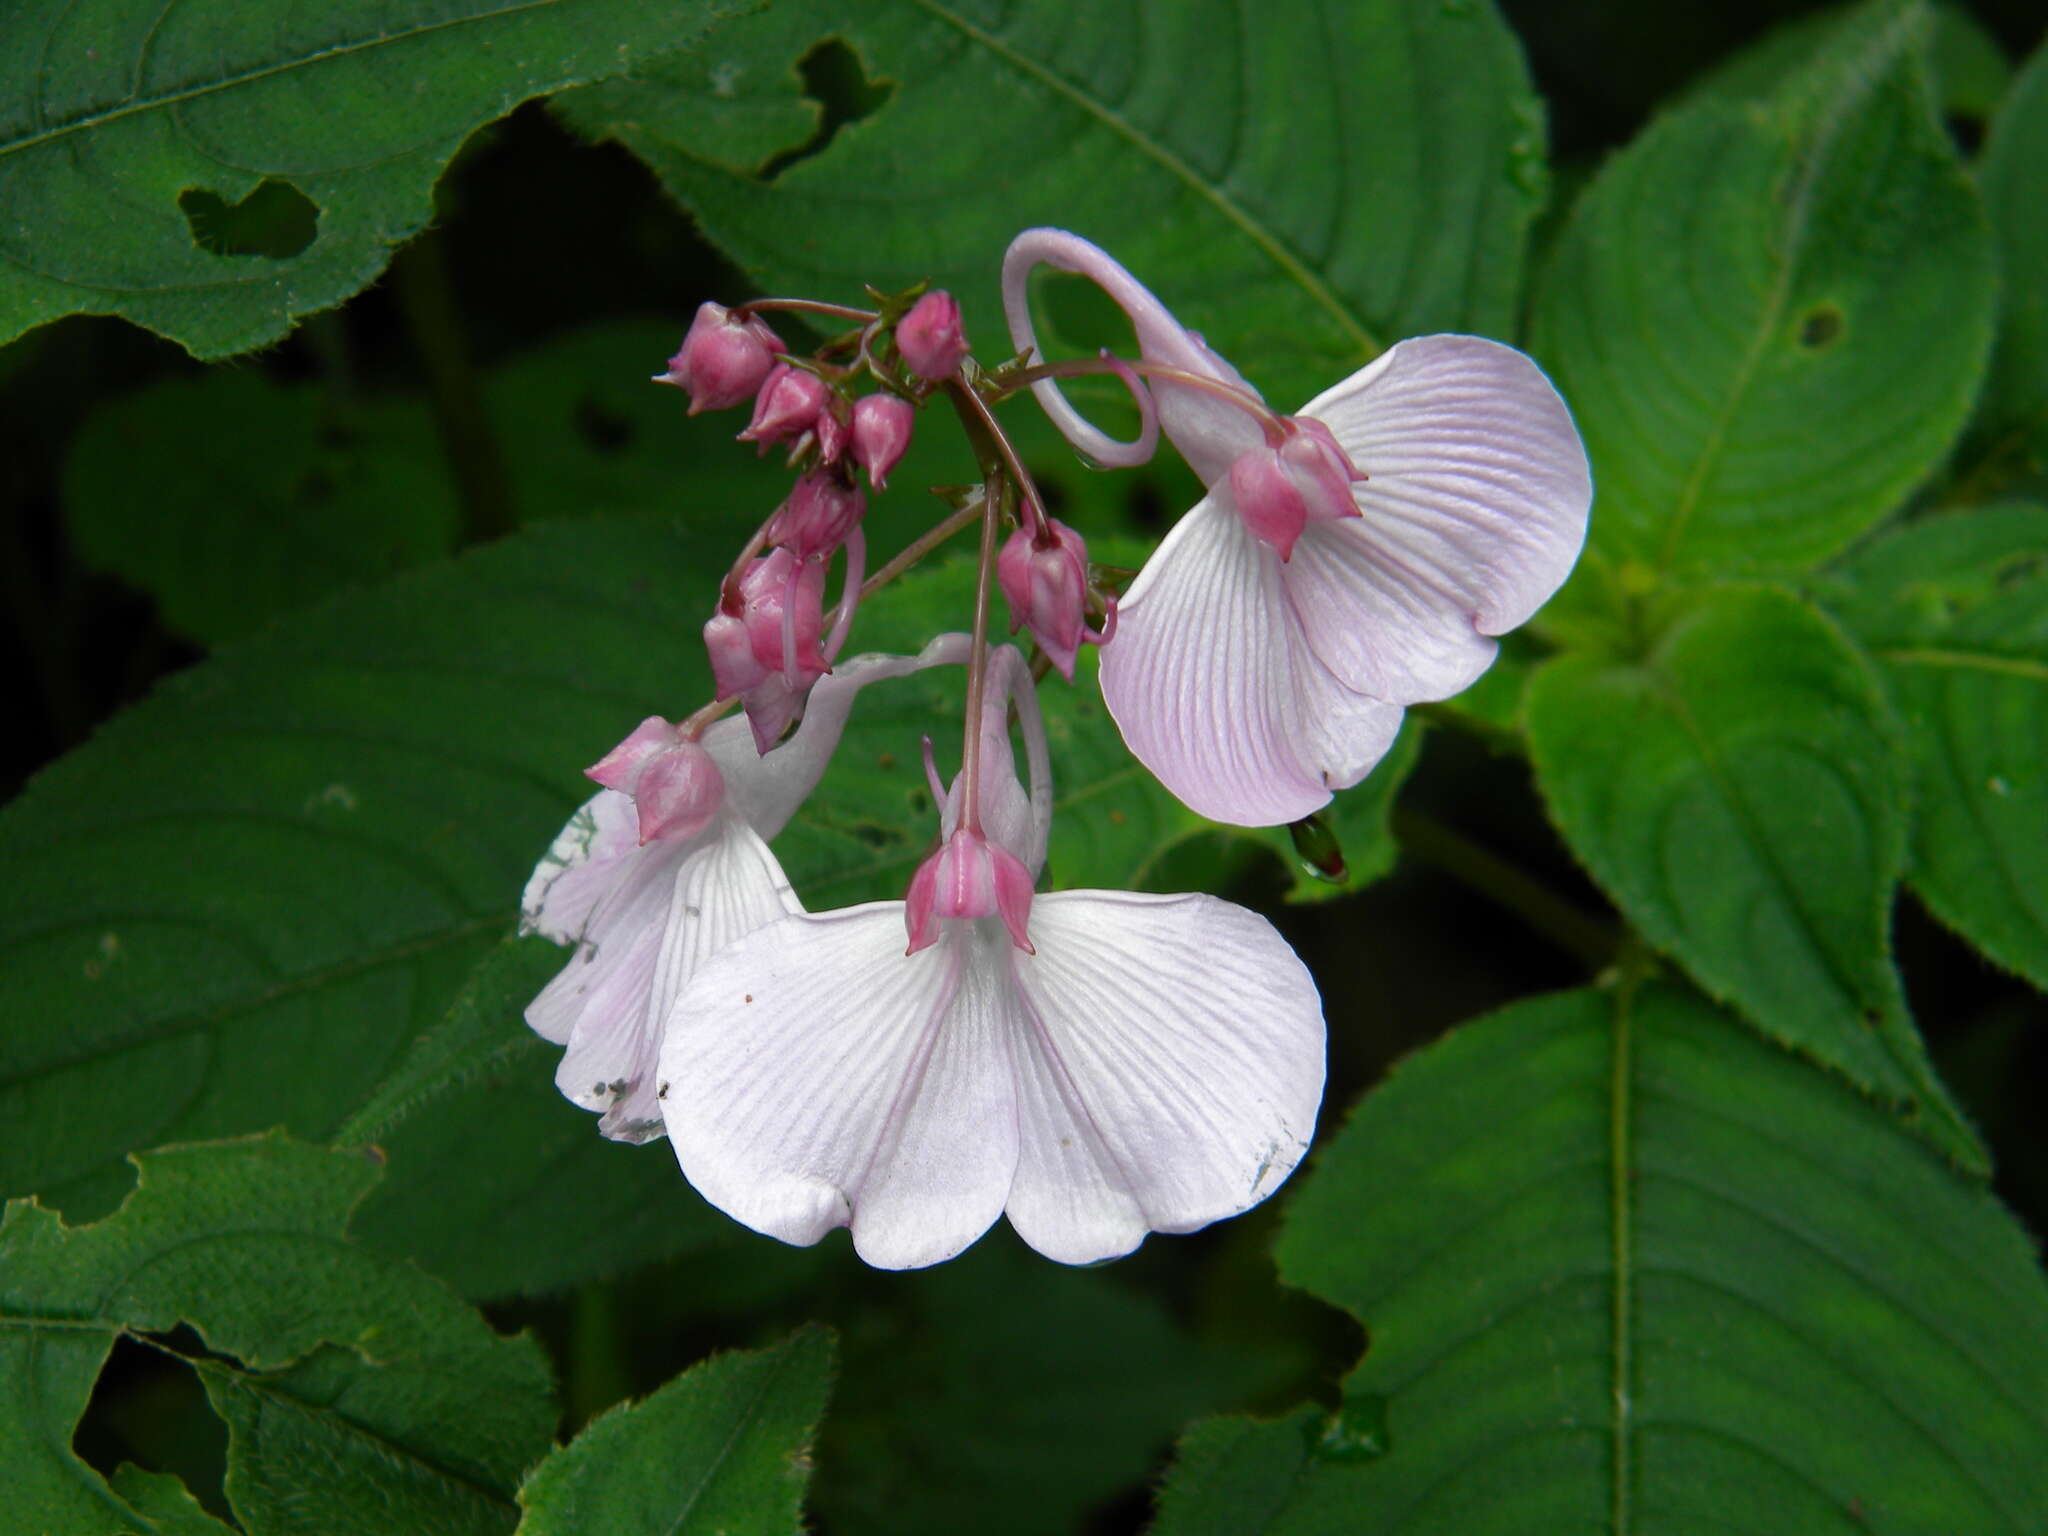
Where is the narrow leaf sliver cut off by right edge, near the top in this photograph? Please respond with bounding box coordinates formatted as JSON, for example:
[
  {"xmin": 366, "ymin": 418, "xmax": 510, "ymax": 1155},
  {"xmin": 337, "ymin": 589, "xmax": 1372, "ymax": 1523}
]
[{"xmin": 1978, "ymin": 45, "xmax": 2048, "ymax": 469}]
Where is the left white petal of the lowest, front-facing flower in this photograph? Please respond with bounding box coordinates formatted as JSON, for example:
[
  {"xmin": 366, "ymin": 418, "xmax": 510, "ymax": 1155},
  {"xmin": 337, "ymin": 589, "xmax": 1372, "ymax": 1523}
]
[{"xmin": 662, "ymin": 901, "xmax": 1018, "ymax": 1270}]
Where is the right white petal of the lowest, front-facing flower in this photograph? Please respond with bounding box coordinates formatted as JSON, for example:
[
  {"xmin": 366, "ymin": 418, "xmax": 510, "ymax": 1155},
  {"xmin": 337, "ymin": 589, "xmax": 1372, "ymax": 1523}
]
[{"xmin": 1008, "ymin": 891, "xmax": 1323, "ymax": 1264}]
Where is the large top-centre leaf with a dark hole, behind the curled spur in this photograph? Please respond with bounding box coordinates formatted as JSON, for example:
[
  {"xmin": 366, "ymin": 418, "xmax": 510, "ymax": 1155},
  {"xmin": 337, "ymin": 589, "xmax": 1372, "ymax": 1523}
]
[{"xmin": 557, "ymin": 0, "xmax": 1546, "ymax": 403}]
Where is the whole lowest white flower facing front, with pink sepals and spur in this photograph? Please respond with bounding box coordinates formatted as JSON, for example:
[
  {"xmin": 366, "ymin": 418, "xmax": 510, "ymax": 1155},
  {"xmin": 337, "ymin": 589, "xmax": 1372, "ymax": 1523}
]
[{"xmin": 662, "ymin": 647, "xmax": 1323, "ymax": 1270}]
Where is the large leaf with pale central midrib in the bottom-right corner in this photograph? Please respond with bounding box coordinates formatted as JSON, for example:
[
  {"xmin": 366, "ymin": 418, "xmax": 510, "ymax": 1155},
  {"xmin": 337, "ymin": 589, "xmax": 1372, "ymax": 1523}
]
[{"xmin": 1157, "ymin": 987, "xmax": 2048, "ymax": 1536}]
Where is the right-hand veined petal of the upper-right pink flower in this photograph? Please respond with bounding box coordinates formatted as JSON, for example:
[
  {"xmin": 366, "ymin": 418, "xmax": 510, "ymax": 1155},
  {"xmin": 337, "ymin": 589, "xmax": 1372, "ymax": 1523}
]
[{"xmin": 1286, "ymin": 336, "xmax": 1593, "ymax": 705}]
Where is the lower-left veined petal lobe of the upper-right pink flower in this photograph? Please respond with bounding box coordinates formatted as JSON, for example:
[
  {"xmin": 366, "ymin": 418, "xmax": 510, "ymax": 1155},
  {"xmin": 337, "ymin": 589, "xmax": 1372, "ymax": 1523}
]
[{"xmin": 1102, "ymin": 494, "xmax": 1329, "ymax": 827}]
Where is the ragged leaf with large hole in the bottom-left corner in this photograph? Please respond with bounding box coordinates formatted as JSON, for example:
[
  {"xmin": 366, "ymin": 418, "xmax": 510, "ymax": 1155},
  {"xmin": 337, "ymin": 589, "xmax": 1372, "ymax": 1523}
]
[{"xmin": 0, "ymin": 1135, "xmax": 555, "ymax": 1536}]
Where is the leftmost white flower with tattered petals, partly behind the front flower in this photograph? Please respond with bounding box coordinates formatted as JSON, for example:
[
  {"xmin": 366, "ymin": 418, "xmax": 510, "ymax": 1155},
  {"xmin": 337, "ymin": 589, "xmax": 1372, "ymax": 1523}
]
[{"xmin": 520, "ymin": 635, "xmax": 967, "ymax": 1143}]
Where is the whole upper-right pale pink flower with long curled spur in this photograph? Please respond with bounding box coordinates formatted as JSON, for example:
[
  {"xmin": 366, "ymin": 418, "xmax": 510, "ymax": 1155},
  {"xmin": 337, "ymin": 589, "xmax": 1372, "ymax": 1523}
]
[{"xmin": 1004, "ymin": 229, "xmax": 1591, "ymax": 825}]
